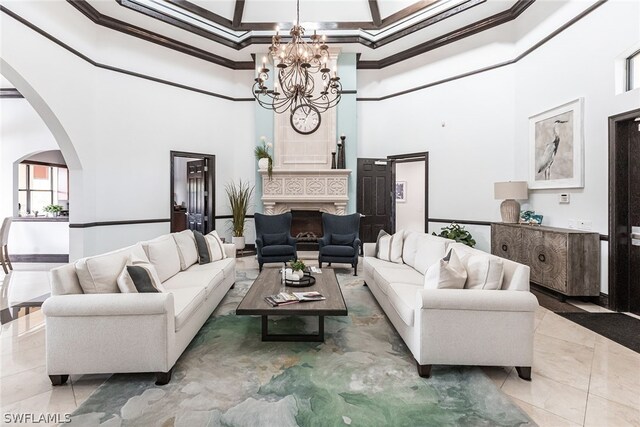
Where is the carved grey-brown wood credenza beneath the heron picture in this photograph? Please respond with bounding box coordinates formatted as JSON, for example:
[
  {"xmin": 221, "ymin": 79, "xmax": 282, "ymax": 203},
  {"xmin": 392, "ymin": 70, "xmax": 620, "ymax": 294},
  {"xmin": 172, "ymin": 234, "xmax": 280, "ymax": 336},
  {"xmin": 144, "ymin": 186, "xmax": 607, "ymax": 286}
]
[{"xmin": 491, "ymin": 223, "xmax": 600, "ymax": 299}]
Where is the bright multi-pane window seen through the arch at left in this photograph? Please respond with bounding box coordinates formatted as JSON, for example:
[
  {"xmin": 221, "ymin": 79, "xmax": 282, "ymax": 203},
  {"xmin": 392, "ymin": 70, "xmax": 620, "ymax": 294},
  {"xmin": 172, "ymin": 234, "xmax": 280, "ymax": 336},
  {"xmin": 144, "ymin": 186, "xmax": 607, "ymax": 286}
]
[{"xmin": 18, "ymin": 163, "xmax": 69, "ymax": 216}]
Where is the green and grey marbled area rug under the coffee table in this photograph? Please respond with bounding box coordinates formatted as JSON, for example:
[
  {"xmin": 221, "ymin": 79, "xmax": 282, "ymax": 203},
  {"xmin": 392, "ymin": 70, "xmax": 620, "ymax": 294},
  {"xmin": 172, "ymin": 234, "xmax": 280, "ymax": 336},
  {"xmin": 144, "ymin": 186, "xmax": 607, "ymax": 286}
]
[{"xmin": 72, "ymin": 270, "xmax": 535, "ymax": 427}]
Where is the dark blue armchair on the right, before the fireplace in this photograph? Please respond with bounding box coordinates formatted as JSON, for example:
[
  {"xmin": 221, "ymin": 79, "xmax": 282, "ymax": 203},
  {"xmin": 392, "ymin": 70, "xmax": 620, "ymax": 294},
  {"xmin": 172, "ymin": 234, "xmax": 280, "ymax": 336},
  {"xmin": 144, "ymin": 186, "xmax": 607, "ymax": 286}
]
[{"xmin": 318, "ymin": 213, "xmax": 361, "ymax": 276}]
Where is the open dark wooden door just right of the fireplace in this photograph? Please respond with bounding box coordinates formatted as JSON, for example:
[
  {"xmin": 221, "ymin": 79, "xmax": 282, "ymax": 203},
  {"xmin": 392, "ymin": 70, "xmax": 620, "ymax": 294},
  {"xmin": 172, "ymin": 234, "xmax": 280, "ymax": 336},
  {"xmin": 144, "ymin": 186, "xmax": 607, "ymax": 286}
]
[{"xmin": 356, "ymin": 159, "xmax": 393, "ymax": 243}]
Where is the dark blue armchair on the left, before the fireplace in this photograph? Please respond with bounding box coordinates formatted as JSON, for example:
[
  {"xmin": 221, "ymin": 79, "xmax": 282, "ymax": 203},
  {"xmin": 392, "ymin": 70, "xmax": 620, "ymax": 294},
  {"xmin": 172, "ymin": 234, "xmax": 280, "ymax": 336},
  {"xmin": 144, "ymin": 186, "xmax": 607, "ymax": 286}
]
[{"xmin": 254, "ymin": 212, "xmax": 298, "ymax": 271}]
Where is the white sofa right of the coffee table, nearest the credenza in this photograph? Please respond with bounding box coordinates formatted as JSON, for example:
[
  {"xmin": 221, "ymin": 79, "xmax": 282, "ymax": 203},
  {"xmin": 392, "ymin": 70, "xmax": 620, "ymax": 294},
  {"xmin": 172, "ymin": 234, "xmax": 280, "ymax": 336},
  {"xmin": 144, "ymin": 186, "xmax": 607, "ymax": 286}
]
[{"xmin": 363, "ymin": 233, "xmax": 538, "ymax": 380}]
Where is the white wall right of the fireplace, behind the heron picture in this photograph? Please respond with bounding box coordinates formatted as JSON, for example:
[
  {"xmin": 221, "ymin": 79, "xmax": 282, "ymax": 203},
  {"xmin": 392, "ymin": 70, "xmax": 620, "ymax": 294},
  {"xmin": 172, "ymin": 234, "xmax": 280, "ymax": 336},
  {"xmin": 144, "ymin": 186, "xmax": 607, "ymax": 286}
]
[{"xmin": 358, "ymin": 1, "xmax": 640, "ymax": 293}]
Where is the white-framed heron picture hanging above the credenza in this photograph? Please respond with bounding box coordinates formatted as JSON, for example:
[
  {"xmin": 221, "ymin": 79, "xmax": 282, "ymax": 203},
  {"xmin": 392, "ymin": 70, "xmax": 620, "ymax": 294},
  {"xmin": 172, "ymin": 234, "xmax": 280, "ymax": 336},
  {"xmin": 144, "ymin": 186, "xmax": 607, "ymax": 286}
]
[{"xmin": 529, "ymin": 98, "xmax": 584, "ymax": 189}]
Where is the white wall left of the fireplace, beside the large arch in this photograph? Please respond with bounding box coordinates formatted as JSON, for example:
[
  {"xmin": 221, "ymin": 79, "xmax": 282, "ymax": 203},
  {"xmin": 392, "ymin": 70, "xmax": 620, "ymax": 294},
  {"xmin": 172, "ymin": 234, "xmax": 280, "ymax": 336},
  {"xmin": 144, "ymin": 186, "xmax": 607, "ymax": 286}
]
[{"xmin": 0, "ymin": 2, "xmax": 254, "ymax": 259}]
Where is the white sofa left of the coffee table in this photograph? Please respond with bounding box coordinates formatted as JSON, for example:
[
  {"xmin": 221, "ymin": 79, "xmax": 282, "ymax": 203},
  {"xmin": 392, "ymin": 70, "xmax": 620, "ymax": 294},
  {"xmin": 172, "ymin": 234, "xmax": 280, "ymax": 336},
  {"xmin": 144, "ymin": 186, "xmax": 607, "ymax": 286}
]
[{"xmin": 42, "ymin": 231, "xmax": 236, "ymax": 385}]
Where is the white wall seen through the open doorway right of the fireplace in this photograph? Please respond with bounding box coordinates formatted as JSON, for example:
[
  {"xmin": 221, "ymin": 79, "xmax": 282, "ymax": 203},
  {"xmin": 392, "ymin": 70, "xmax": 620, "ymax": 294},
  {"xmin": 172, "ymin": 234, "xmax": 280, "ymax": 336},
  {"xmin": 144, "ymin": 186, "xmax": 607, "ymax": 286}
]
[{"xmin": 396, "ymin": 161, "xmax": 426, "ymax": 233}]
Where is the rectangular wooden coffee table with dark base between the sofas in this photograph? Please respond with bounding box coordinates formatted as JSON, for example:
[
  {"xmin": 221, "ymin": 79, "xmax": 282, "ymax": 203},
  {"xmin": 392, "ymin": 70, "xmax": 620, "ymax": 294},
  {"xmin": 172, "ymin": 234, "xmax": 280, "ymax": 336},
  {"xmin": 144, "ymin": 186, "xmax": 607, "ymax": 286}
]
[{"xmin": 236, "ymin": 268, "xmax": 347, "ymax": 342}]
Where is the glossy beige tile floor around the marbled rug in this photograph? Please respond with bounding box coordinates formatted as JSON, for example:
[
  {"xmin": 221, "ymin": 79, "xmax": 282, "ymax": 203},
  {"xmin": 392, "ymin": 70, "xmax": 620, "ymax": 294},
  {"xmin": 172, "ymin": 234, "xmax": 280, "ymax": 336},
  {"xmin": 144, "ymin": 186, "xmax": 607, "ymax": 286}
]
[{"xmin": 0, "ymin": 254, "xmax": 640, "ymax": 427}]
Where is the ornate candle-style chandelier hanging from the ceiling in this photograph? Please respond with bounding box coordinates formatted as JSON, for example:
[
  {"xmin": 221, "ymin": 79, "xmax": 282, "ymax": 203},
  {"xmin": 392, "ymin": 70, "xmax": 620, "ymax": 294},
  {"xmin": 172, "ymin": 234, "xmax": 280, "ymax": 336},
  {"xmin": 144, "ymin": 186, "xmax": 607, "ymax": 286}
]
[{"xmin": 253, "ymin": 0, "xmax": 342, "ymax": 113}]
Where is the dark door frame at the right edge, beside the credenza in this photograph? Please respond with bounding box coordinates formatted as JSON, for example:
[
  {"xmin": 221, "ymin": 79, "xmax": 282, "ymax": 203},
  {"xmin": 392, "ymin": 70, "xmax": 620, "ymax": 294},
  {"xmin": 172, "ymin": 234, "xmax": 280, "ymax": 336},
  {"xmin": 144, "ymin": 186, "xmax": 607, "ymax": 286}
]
[{"xmin": 608, "ymin": 109, "xmax": 640, "ymax": 311}]
